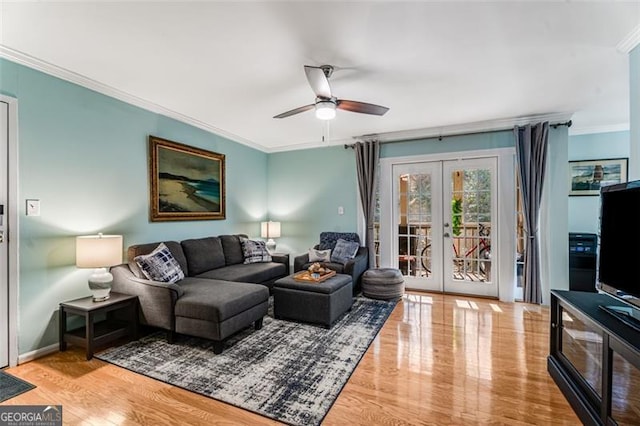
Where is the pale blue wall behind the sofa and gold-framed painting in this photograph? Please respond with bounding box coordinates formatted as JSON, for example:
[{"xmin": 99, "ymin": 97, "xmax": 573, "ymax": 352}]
[{"xmin": 0, "ymin": 59, "xmax": 267, "ymax": 354}]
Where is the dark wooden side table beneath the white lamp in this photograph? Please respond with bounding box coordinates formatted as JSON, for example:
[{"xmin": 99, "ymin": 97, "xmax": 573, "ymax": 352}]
[{"xmin": 59, "ymin": 292, "xmax": 138, "ymax": 360}]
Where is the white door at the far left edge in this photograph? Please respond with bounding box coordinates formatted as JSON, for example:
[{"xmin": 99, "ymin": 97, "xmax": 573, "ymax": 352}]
[{"xmin": 0, "ymin": 102, "xmax": 9, "ymax": 368}]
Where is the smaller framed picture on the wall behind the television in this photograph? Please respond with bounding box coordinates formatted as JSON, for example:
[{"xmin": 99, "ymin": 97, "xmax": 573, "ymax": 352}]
[{"xmin": 569, "ymin": 158, "xmax": 628, "ymax": 195}]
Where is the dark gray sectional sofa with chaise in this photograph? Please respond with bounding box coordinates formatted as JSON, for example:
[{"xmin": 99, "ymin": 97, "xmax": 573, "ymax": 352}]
[{"xmin": 111, "ymin": 235, "xmax": 289, "ymax": 353}]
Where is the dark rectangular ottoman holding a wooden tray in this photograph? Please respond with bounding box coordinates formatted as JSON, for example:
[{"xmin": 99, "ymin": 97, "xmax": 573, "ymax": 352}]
[{"xmin": 273, "ymin": 274, "xmax": 353, "ymax": 328}]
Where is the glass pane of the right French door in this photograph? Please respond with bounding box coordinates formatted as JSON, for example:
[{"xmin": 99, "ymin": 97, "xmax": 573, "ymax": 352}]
[{"xmin": 451, "ymin": 169, "xmax": 492, "ymax": 282}]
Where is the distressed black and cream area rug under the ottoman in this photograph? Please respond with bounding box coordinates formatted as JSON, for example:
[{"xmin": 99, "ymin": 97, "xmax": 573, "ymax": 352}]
[{"xmin": 95, "ymin": 298, "xmax": 396, "ymax": 425}]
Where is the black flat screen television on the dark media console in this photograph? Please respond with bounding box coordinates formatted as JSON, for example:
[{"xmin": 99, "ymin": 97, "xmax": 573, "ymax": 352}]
[{"xmin": 598, "ymin": 181, "xmax": 640, "ymax": 331}]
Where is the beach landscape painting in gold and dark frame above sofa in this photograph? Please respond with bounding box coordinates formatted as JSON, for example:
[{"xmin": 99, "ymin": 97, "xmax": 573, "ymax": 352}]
[{"xmin": 149, "ymin": 136, "xmax": 225, "ymax": 222}]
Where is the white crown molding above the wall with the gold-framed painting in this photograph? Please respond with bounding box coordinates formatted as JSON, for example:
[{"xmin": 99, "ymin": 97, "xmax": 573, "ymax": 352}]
[{"xmin": 0, "ymin": 44, "xmax": 269, "ymax": 153}]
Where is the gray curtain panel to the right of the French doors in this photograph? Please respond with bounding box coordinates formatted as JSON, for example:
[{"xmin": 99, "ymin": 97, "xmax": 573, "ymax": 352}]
[{"xmin": 513, "ymin": 122, "xmax": 549, "ymax": 304}]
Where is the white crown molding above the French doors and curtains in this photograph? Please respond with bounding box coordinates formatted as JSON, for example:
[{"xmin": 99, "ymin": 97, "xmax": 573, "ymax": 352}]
[{"xmin": 354, "ymin": 112, "xmax": 573, "ymax": 142}]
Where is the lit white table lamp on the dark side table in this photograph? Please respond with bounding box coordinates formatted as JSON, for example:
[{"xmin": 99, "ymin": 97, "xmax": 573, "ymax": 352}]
[{"xmin": 76, "ymin": 234, "xmax": 122, "ymax": 302}]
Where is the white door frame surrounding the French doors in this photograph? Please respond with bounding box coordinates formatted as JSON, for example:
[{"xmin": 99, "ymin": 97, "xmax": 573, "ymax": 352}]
[{"xmin": 379, "ymin": 147, "xmax": 516, "ymax": 302}]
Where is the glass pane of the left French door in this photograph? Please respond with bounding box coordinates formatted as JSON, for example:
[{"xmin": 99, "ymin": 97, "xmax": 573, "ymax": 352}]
[{"xmin": 397, "ymin": 174, "xmax": 432, "ymax": 277}]
